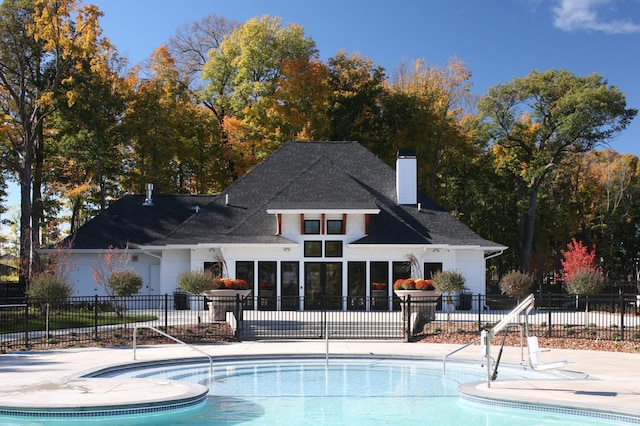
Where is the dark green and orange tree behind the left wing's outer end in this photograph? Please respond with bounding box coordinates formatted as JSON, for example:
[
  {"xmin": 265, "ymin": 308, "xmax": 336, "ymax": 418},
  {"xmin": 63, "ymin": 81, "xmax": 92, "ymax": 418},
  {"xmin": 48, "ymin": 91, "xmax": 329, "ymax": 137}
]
[{"xmin": 45, "ymin": 32, "xmax": 131, "ymax": 233}]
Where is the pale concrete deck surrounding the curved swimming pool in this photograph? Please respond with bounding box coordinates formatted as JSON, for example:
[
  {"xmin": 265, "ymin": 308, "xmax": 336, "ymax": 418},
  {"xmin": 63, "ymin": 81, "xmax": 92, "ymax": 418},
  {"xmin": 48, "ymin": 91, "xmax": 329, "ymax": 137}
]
[{"xmin": 0, "ymin": 340, "xmax": 640, "ymax": 418}]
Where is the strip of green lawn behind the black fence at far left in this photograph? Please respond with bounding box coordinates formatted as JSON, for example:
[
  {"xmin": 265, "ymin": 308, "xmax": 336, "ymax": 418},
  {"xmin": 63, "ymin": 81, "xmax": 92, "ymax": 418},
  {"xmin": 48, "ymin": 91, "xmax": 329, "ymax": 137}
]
[{"xmin": 0, "ymin": 311, "xmax": 157, "ymax": 333}]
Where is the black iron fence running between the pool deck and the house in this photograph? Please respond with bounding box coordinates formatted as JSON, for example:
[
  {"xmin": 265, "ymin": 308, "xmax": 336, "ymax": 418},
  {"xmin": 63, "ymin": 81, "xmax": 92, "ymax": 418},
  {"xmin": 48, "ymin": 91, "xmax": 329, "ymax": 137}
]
[{"xmin": 0, "ymin": 293, "xmax": 640, "ymax": 351}]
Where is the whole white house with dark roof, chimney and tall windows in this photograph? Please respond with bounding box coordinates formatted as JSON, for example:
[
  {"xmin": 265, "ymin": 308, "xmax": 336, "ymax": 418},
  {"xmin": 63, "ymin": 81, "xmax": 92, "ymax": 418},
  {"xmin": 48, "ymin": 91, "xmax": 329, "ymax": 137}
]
[{"xmin": 62, "ymin": 142, "xmax": 506, "ymax": 310}]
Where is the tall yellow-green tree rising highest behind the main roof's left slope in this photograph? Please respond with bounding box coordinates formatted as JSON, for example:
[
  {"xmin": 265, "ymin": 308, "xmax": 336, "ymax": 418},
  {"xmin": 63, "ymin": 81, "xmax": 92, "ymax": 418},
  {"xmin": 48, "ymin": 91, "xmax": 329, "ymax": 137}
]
[{"xmin": 203, "ymin": 16, "xmax": 316, "ymax": 180}]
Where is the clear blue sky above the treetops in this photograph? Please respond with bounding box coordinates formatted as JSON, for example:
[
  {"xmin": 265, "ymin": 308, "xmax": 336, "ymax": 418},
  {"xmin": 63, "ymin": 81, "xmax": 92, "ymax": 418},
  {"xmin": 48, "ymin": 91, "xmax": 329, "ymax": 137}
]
[{"xmin": 90, "ymin": 0, "xmax": 640, "ymax": 156}]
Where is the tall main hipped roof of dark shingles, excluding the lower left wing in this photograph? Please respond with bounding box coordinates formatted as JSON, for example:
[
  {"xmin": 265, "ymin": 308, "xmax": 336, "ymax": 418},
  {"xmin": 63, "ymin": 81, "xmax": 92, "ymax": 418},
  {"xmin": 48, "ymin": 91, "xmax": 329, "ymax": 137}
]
[{"xmin": 141, "ymin": 142, "xmax": 504, "ymax": 249}]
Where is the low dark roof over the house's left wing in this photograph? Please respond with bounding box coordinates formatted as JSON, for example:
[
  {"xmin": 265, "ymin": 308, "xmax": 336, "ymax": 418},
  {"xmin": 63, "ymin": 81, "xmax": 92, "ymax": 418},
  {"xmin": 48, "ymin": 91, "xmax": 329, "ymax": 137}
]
[{"xmin": 63, "ymin": 195, "xmax": 214, "ymax": 250}]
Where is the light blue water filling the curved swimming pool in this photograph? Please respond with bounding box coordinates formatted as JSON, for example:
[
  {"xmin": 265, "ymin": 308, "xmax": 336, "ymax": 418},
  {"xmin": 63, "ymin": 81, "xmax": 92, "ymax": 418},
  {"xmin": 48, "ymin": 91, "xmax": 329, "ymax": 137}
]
[{"xmin": 0, "ymin": 358, "xmax": 632, "ymax": 426}]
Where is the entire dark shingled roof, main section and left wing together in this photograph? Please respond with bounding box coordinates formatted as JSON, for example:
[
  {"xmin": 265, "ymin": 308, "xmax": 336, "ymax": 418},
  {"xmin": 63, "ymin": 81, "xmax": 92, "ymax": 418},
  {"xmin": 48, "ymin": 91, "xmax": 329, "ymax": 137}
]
[{"xmin": 66, "ymin": 142, "xmax": 502, "ymax": 249}]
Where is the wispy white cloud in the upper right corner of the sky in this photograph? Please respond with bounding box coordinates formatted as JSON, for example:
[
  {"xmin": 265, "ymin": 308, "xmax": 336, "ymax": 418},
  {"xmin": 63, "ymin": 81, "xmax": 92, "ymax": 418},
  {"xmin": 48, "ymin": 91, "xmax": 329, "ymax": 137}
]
[{"xmin": 553, "ymin": 0, "xmax": 640, "ymax": 34}]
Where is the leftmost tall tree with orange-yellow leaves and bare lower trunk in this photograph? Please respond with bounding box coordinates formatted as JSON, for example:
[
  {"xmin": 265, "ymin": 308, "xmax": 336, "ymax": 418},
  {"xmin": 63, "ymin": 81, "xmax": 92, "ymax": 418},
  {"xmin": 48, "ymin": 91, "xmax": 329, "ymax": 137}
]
[{"xmin": 0, "ymin": 0, "xmax": 106, "ymax": 288}]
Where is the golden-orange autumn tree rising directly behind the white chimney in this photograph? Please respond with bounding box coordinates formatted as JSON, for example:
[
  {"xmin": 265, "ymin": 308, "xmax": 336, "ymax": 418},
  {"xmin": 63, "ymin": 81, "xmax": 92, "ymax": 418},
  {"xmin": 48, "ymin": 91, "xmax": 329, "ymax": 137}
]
[{"xmin": 384, "ymin": 58, "xmax": 477, "ymax": 201}]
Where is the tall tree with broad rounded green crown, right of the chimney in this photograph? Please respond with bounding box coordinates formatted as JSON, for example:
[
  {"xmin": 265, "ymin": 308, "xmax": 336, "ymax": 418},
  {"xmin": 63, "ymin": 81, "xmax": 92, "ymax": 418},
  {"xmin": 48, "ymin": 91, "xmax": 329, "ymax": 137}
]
[{"xmin": 479, "ymin": 69, "xmax": 637, "ymax": 271}]
